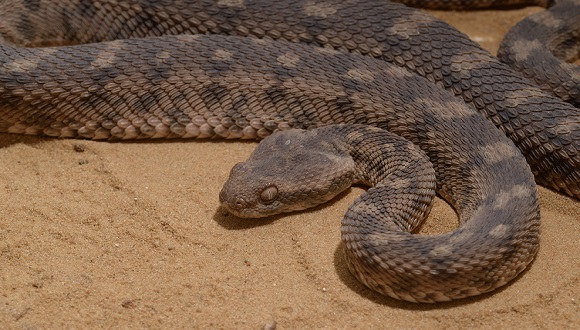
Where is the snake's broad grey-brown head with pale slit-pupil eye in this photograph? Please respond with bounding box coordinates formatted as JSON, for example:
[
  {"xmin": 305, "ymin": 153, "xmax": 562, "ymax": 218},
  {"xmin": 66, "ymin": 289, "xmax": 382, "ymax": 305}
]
[{"xmin": 219, "ymin": 130, "xmax": 355, "ymax": 218}]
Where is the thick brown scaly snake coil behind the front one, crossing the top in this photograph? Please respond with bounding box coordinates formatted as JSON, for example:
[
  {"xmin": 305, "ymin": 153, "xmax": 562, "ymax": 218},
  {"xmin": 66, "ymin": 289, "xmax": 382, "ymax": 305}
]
[{"xmin": 0, "ymin": 0, "xmax": 580, "ymax": 198}]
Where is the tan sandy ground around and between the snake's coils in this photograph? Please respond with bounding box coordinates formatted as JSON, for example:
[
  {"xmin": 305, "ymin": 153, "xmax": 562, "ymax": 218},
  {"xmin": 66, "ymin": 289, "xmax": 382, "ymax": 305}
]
[{"xmin": 0, "ymin": 8, "xmax": 580, "ymax": 329}]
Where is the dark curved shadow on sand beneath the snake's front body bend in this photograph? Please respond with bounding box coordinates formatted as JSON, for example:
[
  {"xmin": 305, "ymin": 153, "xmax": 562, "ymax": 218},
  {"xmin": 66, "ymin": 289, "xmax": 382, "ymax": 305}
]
[{"xmin": 334, "ymin": 242, "xmax": 535, "ymax": 311}]
